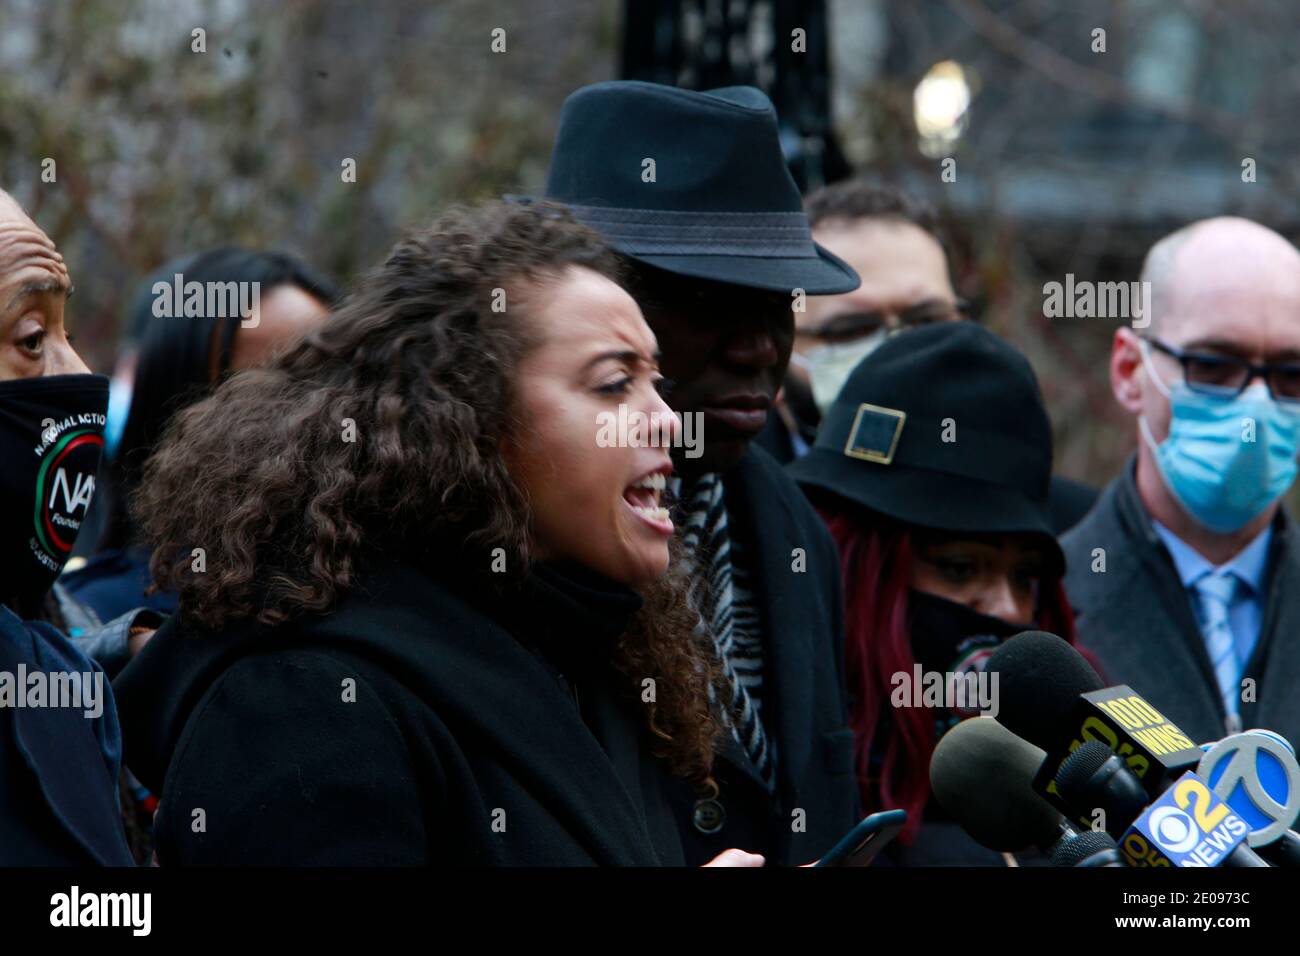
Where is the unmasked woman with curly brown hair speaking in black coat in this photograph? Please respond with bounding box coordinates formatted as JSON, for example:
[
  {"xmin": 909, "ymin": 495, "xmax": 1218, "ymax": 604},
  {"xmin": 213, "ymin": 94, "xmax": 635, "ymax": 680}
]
[{"xmin": 117, "ymin": 203, "xmax": 759, "ymax": 865}]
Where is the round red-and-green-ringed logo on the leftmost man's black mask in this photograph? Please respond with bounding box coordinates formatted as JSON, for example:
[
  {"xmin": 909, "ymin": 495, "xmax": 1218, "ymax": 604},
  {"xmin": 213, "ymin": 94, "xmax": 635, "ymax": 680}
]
[{"xmin": 31, "ymin": 412, "xmax": 104, "ymax": 572}]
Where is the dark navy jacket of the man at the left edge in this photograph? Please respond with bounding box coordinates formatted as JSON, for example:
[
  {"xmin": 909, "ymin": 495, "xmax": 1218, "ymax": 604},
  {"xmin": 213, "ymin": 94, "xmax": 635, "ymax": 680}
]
[{"xmin": 0, "ymin": 606, "xmax": 135, "ymax": 866}]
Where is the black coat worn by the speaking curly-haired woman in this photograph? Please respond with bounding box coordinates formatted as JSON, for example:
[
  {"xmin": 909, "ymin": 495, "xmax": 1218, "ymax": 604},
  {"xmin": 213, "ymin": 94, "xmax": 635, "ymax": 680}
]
[{"xmin": 114, "ymin": 561, "xmax": 683, "ymax": 866}]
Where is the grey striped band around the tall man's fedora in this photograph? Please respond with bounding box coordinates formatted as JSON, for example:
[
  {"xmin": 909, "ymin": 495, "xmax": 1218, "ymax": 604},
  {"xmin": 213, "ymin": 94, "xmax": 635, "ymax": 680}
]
[{"xmin": 568, "ymin": 204, "xmax": 818, "ymax": 259}]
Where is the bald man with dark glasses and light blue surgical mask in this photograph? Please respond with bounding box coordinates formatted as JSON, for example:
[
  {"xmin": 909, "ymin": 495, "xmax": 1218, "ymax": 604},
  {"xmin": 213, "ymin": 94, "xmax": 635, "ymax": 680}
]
[{"xmin": 1062, "ymin": 217, "xmax": 1300, "ymax": 741}]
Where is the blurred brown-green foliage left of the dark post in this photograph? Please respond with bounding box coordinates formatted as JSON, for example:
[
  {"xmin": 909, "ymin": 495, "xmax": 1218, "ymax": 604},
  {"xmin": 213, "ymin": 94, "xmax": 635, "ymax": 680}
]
[{"xmin": 0, "ymin": 0, "xmax": 619, "ymax": 369}]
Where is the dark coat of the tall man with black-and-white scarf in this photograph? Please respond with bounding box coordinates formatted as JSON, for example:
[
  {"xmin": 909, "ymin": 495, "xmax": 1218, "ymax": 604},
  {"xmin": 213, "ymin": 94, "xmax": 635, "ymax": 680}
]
[{"xmin": 660, "ymin": 445, "xmax": 858, "ymax": 865}]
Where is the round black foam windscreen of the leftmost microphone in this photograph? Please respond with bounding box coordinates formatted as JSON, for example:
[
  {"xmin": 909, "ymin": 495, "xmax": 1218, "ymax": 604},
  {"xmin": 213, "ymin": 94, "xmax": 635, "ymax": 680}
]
[{"xmin": 930, "ymin": 717, "xmax": 1062, "ymax": 852}]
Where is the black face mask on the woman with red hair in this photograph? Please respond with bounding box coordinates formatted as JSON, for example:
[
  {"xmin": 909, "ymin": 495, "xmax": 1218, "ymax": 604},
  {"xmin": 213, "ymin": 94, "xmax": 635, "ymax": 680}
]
[{"xmin": 909, "ymin": 591, "xmax": 1034, "ymax": 739}]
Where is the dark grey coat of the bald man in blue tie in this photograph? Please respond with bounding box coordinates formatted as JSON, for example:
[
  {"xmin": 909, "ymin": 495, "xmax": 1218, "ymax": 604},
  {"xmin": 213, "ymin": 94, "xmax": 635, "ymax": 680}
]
[{"xmin": 1061, "ymin": 459, "xmax": 1300, "ymax": 743}]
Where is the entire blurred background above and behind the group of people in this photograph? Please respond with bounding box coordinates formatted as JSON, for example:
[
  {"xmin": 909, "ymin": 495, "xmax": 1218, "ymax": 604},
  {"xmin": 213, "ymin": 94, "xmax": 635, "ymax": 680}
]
[{"xmin": 0, "ymin": 0, "xmax": 1300, "ymax": 484}]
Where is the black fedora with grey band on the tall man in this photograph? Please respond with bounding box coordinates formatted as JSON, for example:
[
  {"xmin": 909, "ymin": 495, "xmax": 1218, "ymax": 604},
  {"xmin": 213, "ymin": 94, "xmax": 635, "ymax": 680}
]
[{"xmin": 546, "ymin": 81, "xmax": 859, "ymax": 295}]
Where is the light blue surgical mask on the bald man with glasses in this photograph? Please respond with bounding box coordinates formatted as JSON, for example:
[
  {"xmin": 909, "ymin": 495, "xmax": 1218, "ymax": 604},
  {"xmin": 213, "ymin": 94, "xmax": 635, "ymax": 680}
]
[{"xmin": 1138, "ymin": 342, "xmax": 1300, "ymax": 532}]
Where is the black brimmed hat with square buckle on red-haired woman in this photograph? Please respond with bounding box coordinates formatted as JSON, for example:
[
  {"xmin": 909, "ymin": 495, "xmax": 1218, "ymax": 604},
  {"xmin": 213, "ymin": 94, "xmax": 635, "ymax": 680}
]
[{"xmin": 789, "ymin": 321, "xmax": 1065, "ymax": 572}]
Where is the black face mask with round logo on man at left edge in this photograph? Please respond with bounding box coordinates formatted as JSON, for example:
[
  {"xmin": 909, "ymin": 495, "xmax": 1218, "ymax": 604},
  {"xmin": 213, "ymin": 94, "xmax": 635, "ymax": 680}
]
[{"xmin": 0, "ymin": 375, "xmax": 108, "ymax": 606}]
